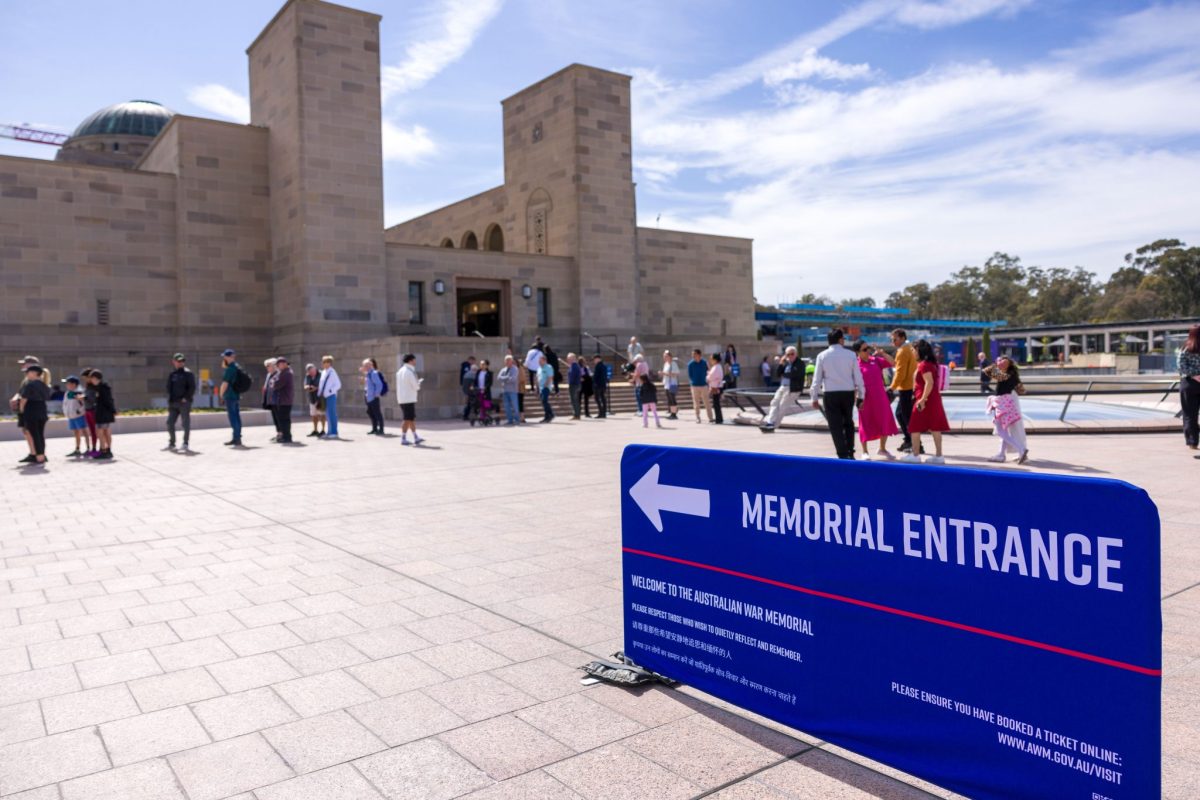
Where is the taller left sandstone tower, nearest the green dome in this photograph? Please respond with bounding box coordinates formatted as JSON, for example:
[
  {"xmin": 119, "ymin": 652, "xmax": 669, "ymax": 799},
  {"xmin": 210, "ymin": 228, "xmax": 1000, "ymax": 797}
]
[{"xmin": 246, "ymin": 0, "xmax": 388, "ymax": 349}]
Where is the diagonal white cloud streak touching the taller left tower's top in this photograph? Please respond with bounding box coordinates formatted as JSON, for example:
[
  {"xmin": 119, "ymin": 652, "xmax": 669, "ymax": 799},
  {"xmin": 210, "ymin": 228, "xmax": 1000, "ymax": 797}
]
[{"xmin": 382, "ymin": 0, "xmax": 503, "ymax": 100}]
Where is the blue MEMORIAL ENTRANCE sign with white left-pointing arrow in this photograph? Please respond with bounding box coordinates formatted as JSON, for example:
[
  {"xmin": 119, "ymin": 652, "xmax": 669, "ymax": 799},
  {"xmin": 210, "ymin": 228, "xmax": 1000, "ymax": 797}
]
[{"xmin": 620, "ymin": 445, "xmax": 1162, "ymax": 800}]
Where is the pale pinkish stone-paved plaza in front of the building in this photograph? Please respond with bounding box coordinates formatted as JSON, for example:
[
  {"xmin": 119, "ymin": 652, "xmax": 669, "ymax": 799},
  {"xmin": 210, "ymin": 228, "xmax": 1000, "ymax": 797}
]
[{"xmin": 0, "ymin": 416, "xmax": 1200, "ymax": 800}]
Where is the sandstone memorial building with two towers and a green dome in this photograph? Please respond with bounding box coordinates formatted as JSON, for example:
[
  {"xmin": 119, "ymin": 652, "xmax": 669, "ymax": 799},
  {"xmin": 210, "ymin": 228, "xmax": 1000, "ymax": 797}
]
[{"xmin": 0, "ymin": 0, "xmax": 755, "ymax": 408}]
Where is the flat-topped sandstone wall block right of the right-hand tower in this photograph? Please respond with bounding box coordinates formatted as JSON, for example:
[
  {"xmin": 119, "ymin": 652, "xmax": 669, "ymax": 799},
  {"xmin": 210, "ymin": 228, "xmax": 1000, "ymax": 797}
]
[{"xmin": 637, "ymin": 228, "xmax": 756, "ymax": 342}]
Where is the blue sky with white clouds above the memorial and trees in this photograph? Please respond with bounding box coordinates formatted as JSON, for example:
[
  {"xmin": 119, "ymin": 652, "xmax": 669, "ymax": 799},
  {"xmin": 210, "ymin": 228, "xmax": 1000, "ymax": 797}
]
[{"xmin": 0, "ymin": 0, "xmax": 1200, "ymax": 302}]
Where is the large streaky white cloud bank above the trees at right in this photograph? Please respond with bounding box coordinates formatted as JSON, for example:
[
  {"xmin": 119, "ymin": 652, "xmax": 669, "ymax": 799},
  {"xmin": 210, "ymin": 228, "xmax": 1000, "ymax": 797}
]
[{"xmin": 634, "ymin": 4, "xmax": 1200, "ymax": 300}]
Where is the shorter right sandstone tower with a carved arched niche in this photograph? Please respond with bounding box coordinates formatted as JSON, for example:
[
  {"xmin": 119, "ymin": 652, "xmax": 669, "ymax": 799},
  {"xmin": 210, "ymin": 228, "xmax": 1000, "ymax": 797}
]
[{"xmin": 502, "ymin": 64, "xmax": 638, "ymax": 335}]
